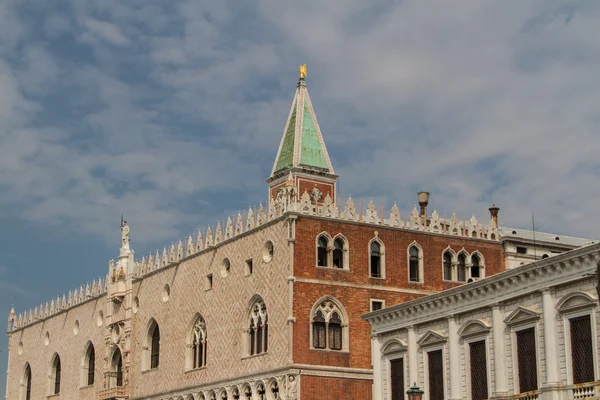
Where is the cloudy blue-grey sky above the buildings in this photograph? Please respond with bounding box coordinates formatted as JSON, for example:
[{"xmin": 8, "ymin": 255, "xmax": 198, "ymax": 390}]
[{"xmin": 0, "ymin": 0, "xmax": 600, "ymax": 393}]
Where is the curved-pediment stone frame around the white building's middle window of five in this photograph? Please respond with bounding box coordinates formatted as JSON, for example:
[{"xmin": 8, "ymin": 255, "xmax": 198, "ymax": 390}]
[{"xmin": 458, "ymin": 320, "xmax": 492, "ymax": 400}]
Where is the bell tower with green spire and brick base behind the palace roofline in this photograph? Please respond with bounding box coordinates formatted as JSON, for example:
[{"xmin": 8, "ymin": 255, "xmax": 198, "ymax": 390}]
[{"xmin": 267, "ymin": 64, "xmax": 338, "ymax": 203}]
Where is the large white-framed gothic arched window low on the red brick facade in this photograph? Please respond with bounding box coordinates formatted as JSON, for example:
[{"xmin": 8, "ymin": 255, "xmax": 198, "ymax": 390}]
[{"xmin": 311, "ymin": 299, "xmax": 348, "ymax": 350}]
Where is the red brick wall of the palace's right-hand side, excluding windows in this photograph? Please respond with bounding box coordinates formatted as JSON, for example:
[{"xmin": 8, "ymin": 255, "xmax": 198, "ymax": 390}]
[{"xmin": 293, "ymin": 216, "xmax": 505, "ymax": 399}]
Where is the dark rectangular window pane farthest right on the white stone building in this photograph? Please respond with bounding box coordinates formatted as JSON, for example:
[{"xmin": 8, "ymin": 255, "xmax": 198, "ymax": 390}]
[{"xmin": 569, "ymin": 315, "xmax": 594, "ymax": 384}]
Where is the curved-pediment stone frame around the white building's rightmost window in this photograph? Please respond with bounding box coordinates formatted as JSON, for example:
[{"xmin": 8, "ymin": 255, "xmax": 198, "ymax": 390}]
[{"xmin": 556, "ymin": 291, "xmax": 600, "ymax": 385}]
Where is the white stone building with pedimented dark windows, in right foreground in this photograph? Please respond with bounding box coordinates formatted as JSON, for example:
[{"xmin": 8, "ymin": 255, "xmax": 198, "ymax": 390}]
[{"xmin": 364, "ymin": 244, "xmax": 600, "ymax": 400}]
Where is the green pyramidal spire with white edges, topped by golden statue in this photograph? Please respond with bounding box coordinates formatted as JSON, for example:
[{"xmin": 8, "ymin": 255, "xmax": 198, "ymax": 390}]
[{"xmin": 271, "ymin": 69, "xmax": 335, "ymax": 177}]
